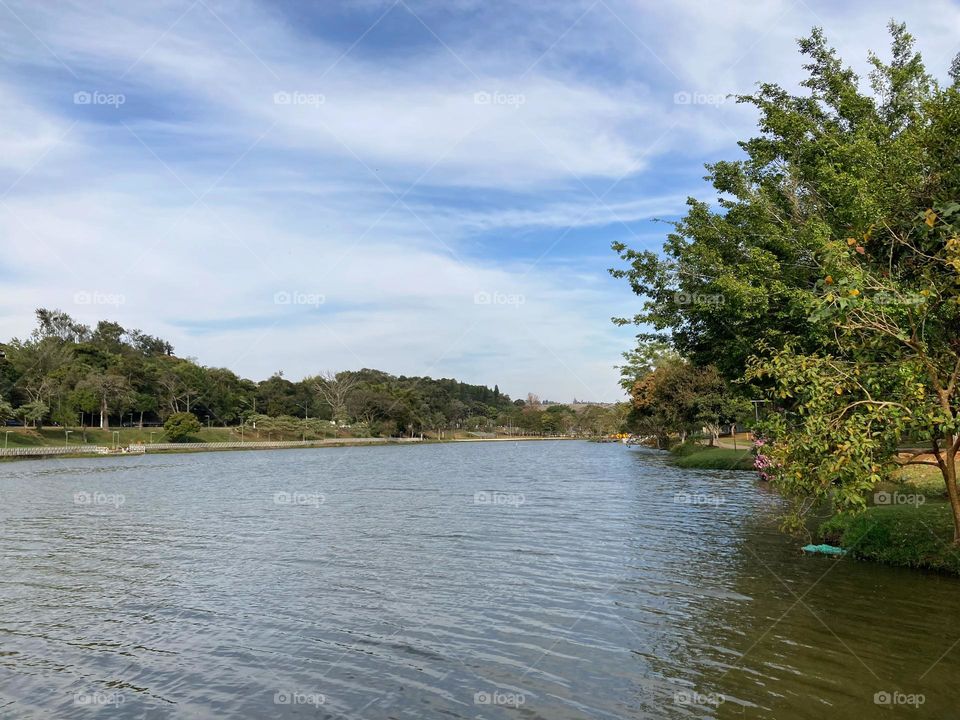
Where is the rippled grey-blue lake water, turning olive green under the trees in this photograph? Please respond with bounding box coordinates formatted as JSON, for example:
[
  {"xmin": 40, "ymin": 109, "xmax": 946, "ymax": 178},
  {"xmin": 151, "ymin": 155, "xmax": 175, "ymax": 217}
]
[{"xmin": 0, "ymin": 442, "xmax": 960, "ymax": 720}]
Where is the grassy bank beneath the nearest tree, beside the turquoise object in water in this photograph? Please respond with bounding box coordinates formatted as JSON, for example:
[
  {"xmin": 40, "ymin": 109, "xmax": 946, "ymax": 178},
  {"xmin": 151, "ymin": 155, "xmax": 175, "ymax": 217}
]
[{"xmin": 820, "ymin": 502, "xmax": 960, "ymax": 575}]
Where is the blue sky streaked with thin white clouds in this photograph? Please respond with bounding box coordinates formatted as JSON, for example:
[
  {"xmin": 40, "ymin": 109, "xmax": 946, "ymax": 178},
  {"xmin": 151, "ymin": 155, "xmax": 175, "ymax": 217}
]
[{"xmin": 0, "ymin": 0, "xmax": 960, "ymax": 402}]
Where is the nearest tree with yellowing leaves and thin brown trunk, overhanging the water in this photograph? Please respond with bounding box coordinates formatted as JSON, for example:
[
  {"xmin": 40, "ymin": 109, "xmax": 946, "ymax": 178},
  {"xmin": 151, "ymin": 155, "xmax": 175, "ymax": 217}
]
[{"xmin": 752, "ymin": 203, "xmax": 960, "ymax": 544}]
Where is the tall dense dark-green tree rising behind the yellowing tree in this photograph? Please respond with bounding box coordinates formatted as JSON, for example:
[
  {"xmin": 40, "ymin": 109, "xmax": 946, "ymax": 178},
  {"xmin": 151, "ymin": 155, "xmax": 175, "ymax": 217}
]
[{"xmin": 612, "ymin": 24, "xmax": 936, "ymax": 380}]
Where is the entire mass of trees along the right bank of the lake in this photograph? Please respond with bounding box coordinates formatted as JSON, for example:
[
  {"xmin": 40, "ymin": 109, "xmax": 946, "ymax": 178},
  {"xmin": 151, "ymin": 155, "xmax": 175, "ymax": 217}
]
[{"xmin": 613, "ymin": 23, "xmax": 960, "ymax": 544}]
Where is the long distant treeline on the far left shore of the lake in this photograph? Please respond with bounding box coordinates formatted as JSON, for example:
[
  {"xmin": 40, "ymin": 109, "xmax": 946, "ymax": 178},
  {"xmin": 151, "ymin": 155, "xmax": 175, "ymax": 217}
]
[{"xmin": 0, "ymin": 309, "xmax": 617, "ymax": 436}]
